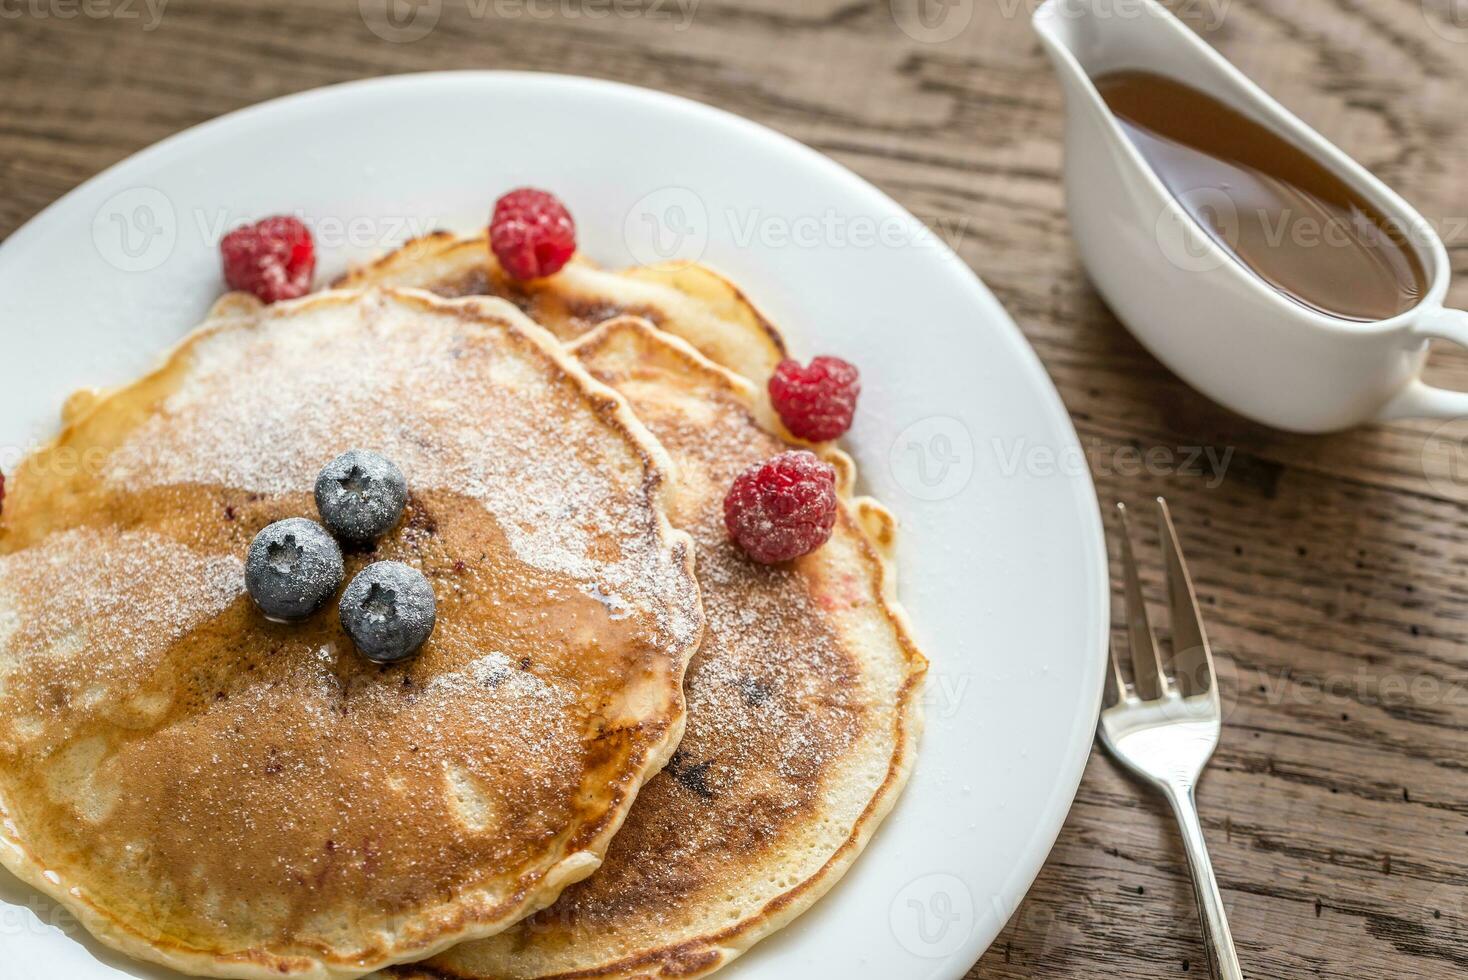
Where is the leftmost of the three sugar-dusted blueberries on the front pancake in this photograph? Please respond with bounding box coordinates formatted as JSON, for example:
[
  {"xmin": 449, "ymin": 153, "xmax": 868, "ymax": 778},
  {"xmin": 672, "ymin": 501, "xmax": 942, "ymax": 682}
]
[{"xmin": 245, "ymin": 518, "xmax": 346, "ymax": 621}]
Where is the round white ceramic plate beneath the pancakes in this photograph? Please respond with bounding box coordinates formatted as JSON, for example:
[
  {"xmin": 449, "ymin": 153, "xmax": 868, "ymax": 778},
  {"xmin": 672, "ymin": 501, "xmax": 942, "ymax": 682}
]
[{"xmin": 0, "ymin": 73, "xmax": 1108, "ymax": 980}]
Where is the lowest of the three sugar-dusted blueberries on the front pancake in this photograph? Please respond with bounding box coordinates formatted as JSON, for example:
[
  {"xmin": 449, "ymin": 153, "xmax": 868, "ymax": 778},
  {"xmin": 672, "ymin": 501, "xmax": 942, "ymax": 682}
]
[{"xmin": 341, "ymin": 562, "xmax": 437, "ymax": 663}]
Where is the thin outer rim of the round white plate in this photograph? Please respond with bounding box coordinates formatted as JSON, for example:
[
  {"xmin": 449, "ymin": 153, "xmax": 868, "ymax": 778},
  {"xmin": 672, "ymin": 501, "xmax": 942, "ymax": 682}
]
[{"xmin": 0, "ymin": 69, "xmax": 1111, "ymax": 980}]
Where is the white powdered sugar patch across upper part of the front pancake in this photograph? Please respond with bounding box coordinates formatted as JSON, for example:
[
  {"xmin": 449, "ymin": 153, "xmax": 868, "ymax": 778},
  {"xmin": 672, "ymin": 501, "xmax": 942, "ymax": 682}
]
[{"xmin": 104, "ymin": 296, "xmax": 693, "ymax": 646}]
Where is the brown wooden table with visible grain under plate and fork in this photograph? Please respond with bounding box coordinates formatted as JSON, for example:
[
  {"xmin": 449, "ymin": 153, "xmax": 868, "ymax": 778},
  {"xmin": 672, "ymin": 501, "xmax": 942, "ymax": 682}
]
[{"xmin": 0, "ymin": 0, "xmax": 1468, "ymax": 980}]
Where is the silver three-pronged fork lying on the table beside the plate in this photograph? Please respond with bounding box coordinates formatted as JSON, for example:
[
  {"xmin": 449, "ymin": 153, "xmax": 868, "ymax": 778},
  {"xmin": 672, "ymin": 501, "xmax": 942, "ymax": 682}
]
[{"xmin": 1100, "ymin": 497, "xmax": 1243, "ymax": 980}]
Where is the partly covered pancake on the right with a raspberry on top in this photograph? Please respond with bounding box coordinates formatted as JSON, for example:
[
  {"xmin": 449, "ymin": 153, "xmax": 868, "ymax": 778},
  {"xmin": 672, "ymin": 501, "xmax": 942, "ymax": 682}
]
[{"xmin": 389, "ymin": 318, "xmax": 926, "ymax": 980}]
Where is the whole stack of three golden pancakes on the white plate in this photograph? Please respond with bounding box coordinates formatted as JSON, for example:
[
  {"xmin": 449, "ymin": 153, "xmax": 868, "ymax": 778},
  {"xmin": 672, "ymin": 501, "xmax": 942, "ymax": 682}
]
[{"xmin": 0, "ymin": 235, "xmax": 926, "ymax": 980}]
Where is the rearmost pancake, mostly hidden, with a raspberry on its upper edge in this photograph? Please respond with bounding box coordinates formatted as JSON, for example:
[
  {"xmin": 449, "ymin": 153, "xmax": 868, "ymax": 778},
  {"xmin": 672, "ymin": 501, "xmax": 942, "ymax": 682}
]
[{"xmin": 336, "ymin": 232, "xmax": 785, "ymax": 392}]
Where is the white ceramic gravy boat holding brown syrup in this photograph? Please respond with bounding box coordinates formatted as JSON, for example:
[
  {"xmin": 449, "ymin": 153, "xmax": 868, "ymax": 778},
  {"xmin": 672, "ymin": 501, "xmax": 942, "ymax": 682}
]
[{"xmin": 1033, "ymin": 0, "xmax": 1468, "ymax": 433}]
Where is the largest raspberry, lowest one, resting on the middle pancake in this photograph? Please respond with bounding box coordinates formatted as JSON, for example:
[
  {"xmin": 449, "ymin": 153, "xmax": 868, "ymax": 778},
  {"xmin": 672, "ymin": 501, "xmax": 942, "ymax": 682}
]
[{"xmin": 724, "ymin": 450, "xmax": 835, "ymax": 565}]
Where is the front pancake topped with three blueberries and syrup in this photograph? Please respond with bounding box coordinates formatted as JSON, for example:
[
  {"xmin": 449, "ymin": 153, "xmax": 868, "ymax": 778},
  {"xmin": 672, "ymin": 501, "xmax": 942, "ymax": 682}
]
[{"xmin": 0, "ymin": 290, "xmax": 702, "ymax": 977}]
